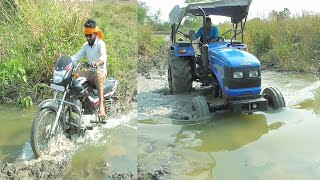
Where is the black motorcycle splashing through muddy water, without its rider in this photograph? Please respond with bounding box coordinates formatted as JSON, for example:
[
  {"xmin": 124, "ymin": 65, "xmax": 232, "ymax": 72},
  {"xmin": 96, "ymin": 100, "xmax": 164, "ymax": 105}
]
[{"xmin": 31, "ymin": 56, "xmax": 118, "ymax": 158}]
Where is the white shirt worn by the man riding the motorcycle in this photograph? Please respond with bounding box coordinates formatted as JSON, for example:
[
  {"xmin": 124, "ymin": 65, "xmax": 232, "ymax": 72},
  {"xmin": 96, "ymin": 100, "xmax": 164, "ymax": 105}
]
[{"xmin": 71, "ymin": 37, "xmax": 107, "ymax": 73}]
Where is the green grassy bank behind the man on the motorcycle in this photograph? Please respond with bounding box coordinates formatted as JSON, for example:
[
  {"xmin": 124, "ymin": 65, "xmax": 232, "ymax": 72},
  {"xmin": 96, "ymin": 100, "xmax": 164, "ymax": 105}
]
[{"xmin": 0, "ymin": 0, "xmax": 137, "ymax": 108}]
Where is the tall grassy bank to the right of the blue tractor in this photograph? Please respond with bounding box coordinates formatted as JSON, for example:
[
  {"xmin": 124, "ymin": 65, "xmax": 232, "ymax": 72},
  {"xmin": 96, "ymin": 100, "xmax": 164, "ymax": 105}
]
[{"xmin": 245, "ymin": 13, "xmax": 320, "ymax": 73}]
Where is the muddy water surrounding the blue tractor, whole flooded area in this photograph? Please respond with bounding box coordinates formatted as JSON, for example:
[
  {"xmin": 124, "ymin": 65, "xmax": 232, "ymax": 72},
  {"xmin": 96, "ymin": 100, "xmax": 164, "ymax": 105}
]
[{"xmin": 137, "ymin": 71, "xmax": 320, "ymax": 179}]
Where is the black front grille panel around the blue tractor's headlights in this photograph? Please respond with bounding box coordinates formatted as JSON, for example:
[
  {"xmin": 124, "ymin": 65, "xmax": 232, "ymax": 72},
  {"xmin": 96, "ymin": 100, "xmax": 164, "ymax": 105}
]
[{"xmin": 223, "ymin": 67, "xmax": 261, "ymax": 89}]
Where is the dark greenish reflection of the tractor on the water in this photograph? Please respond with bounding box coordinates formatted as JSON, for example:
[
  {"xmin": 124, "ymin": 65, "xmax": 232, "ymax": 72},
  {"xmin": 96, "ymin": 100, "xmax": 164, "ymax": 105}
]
[{"xmin": 176, "ymin": 114, "xmax": 268, "ymax": 152}]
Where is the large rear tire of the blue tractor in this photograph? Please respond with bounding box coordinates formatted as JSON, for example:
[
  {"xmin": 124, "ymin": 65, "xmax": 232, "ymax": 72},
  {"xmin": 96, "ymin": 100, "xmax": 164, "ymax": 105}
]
[{"xmin": 168, "ymin": 56, "xmax": 192, "ymax": 94}]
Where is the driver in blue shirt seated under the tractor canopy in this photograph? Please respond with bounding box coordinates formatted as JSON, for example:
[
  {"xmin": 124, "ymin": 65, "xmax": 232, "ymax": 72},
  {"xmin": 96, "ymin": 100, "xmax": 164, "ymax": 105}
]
[{"xmin": 195, "ymin": 17, "xmax": 219, "ymax": 44}]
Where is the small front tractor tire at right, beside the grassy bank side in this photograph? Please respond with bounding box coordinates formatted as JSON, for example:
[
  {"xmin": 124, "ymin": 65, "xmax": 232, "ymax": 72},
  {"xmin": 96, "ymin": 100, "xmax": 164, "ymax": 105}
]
[{"xmin": 262, "ymin": 87, "xmax": 286, "ymax": 110}]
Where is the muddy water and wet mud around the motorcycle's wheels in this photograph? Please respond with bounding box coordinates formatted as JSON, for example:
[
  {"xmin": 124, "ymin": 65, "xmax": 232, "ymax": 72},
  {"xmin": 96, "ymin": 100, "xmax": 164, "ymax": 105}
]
[{"xmin": 0, "ymin": 105, "xmax": 137, "ymax": 179}]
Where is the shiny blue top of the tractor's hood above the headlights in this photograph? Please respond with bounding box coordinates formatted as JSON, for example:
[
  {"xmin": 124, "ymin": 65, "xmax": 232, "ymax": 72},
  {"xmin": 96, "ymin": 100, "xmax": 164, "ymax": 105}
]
[{"xmin": 210, "ymin": 48, "xmax": 260, "ymax": 67}]
